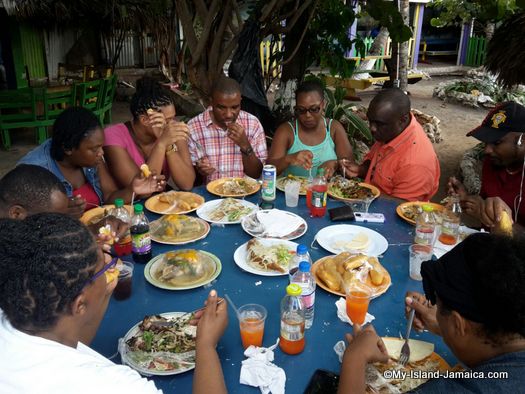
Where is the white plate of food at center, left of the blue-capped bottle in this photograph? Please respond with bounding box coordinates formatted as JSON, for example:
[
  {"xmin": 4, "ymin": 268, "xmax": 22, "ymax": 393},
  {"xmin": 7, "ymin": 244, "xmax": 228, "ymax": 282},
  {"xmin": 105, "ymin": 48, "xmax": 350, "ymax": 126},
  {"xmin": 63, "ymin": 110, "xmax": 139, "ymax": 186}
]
[{"xmin": 233, "ymin": 238, "xmax": 298, "ymax": 276}]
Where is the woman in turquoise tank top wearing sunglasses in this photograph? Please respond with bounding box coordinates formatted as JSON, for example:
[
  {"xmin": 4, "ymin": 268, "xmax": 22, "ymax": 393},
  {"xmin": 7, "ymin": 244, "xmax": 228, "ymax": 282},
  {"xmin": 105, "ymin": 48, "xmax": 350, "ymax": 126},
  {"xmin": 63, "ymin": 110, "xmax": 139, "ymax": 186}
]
[{"xmin": 267, "ymin": 81, "xmax": 353, "ymax": 178}]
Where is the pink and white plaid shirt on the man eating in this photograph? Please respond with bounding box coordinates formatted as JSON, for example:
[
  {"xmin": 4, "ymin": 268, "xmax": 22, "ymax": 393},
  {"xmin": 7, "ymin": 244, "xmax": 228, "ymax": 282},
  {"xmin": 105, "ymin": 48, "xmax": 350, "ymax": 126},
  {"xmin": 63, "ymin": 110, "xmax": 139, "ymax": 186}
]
[{"xmin": 188, "ymin": 107, "xmax": 268, "ymax": 183}]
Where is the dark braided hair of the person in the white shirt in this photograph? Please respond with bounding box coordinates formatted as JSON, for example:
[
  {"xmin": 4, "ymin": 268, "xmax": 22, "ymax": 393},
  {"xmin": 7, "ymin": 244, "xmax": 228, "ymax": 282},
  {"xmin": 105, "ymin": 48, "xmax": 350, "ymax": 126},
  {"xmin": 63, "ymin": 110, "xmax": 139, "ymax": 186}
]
[{"xmin": 0, "ymin": 213, "xmax": 97, "ymax": 332}]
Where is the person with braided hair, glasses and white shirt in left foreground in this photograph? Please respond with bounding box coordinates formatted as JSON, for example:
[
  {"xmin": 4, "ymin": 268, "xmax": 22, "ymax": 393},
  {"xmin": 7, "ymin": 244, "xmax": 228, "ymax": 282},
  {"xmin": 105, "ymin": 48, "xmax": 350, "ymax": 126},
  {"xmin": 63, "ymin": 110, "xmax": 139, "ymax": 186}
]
[{"xmin": 0, "ymin": 213, "xmax": 228, "ymax": 394}]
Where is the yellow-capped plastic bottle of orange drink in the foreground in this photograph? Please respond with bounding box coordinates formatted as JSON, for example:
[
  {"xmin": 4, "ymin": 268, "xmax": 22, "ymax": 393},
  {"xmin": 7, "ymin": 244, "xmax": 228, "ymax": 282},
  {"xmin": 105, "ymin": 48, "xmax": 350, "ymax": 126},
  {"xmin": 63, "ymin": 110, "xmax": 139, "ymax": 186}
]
[{"xmin": 279, "ymin": 284, "xmax": 305, "ymax": 354}]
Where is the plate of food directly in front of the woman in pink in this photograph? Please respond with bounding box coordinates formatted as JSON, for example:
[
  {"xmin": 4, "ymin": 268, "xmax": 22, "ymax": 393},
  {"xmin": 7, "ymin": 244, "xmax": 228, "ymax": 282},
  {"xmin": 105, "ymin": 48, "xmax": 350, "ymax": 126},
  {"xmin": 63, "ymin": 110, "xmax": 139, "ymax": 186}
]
[{"xmin": 144, "ymin": 190, "xmax": 204, "ymax": 215}]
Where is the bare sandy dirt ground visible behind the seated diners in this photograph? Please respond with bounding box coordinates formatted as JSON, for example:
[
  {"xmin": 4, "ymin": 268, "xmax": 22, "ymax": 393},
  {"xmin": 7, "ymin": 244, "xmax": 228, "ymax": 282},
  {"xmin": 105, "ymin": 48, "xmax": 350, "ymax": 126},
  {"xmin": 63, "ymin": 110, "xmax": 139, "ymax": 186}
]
[{"xmin": 0, "ymin": 77, "xmax": 487, "ymax": 201}]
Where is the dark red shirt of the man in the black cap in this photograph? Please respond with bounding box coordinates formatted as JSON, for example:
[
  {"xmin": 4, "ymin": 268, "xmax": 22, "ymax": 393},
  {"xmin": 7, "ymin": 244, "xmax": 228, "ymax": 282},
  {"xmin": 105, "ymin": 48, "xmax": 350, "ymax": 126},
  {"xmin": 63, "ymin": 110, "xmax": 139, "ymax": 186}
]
[{"xmin": 479, "ymin": 157, "xmax": 525, "ymax": 225}]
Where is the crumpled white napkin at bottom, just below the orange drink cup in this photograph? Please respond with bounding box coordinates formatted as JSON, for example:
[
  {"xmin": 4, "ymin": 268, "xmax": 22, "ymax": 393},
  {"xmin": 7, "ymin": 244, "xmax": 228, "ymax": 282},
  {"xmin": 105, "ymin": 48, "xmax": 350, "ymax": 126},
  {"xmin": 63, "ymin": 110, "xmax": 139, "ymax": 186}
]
[{"xmin": 239, "ymin": 339, "xmax": 286, "ymax": 394}]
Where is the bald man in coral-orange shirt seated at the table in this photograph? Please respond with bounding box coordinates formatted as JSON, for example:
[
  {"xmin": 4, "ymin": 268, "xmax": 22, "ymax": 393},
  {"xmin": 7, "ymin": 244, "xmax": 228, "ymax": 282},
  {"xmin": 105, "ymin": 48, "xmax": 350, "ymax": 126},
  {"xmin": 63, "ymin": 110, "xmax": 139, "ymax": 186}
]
[{"xmin": 342, "ymin": 89, "xmax": 440, "ymax": 201}]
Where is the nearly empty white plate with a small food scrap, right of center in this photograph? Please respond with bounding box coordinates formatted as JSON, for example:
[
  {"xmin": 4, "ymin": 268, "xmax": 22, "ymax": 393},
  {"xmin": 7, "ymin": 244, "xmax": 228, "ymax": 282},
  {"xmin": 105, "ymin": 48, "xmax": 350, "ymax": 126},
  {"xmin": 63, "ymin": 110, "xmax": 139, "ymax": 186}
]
[{"xmin": 315, "ymin": 224, "xmax": 388, "ymax": 256}]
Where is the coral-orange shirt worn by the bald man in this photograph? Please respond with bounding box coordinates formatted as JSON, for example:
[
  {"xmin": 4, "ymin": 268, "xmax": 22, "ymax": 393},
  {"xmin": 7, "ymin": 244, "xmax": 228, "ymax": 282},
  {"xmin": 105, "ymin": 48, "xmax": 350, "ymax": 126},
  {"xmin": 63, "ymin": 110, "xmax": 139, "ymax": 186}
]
[{"xmin": 365, "ymin": 115, "xmax": 440, "ymax": 201}]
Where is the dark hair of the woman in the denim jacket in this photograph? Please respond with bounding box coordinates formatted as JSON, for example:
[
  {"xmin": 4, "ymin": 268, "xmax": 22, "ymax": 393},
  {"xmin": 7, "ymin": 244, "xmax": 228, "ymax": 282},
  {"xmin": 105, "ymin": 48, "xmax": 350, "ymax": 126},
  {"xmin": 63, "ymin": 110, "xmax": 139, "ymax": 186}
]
[{"xmin": 51, "ymin": 107, "xmax": 101, "ymax": 161}]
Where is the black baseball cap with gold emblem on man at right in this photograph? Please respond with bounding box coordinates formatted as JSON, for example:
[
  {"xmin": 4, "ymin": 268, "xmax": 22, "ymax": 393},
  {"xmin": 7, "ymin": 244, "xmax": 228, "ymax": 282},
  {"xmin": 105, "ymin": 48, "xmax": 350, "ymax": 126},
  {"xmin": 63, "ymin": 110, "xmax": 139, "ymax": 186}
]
[{"xmin": 467, "ymin": 101, "xmax": 525, "ymax": 144}]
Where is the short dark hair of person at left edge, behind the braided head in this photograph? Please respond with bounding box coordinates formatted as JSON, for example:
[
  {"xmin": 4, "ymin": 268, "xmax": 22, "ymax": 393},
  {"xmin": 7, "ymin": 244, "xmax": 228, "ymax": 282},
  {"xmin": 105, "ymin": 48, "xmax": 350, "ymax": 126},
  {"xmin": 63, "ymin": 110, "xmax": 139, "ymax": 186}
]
[{"xmin": 0, "ymin": 164, "xmax": 66, "ymax": 212}]
